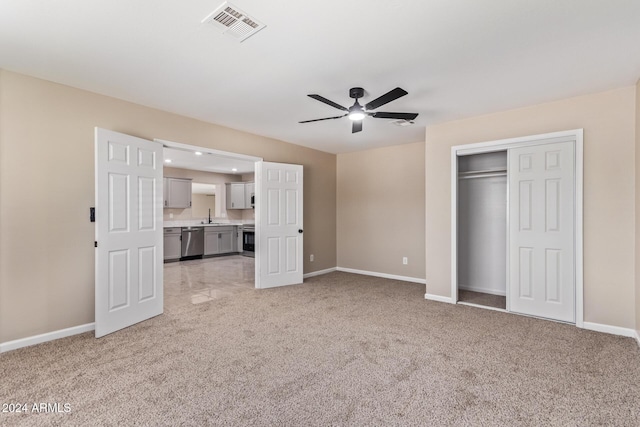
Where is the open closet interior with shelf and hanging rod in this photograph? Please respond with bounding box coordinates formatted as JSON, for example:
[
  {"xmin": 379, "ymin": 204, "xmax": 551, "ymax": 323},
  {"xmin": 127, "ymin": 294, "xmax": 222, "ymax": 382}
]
[{"xmin": 456, "ymin": 150, "xmax": 508, "ymax": 310}]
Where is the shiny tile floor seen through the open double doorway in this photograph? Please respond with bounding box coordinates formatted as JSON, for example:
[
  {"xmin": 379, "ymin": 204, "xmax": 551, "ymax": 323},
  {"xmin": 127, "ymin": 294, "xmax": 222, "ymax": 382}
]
[{"xmin": 164, "ymin": 255, "xmax": 255, "ymax": 307}]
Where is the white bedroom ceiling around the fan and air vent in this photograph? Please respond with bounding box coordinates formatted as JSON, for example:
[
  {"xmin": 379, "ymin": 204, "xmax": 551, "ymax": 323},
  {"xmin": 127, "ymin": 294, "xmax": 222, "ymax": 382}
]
[{"xmin": 0, "ymin": 0, "xmax": 640, "ymax": 153}]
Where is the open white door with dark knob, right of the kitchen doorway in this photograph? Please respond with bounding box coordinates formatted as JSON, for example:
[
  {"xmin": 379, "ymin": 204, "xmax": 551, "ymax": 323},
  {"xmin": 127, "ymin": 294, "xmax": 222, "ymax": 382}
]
[{"xmin": 255, "ymin": 162, "xmax": 303, "ymax": 288}]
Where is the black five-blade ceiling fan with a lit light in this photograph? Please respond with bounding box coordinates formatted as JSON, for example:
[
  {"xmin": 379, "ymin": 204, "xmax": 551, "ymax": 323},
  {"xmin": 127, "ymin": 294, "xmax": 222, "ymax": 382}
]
[{"xmin": 299, "ymin": 87, "xmax": 418, "ymax": 133}]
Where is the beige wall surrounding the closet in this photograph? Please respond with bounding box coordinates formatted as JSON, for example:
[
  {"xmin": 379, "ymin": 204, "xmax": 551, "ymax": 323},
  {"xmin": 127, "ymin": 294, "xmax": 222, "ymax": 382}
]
[{"xmin": 425, "ymin": 87, "xmax": 636, "ymax": 328}]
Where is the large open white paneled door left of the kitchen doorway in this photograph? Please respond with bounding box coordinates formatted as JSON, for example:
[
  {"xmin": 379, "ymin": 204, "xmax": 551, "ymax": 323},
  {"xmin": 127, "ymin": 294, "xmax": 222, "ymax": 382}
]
[{"xmin": 95, "ymin": 128, "xmax": 163, "ymax": 337}]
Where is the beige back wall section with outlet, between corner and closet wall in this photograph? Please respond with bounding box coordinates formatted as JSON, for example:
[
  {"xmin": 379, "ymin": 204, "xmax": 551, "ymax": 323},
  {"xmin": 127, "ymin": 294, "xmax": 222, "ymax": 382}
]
[{"xmin": 337, "ymin": 142, "xmax": 425, "ymax": 279}]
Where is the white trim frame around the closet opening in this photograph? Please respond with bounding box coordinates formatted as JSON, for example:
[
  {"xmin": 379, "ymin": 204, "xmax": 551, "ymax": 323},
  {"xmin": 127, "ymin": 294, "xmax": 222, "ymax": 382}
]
[{"xmin": 451, "ymin": 129, "xmax": 584, "ymax": 328}]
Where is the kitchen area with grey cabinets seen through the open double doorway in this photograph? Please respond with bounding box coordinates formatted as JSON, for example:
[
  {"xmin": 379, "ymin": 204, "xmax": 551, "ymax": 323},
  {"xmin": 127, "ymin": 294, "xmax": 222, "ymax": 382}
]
[{"xmin": 163, "ymin": 147, "xmax": 255, "ymax": 304}]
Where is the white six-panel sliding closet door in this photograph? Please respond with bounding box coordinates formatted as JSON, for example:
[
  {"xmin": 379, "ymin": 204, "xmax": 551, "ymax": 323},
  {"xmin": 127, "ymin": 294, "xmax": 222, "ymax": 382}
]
[{"xmin": 508, "ymin": 141, "xmax": 575, "ymax": 322}]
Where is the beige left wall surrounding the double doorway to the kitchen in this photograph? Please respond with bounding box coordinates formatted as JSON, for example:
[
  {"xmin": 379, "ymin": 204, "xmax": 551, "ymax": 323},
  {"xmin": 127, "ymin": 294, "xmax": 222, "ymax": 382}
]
[{"xmin": 0, "ymin": 71, "xmax": 336, "ymax": 342}]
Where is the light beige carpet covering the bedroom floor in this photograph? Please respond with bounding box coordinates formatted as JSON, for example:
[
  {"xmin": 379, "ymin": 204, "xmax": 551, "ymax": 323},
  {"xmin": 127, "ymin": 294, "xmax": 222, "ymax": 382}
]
[{"xmin": 0, "ymin": 272, "xmax": 640, "ymax": 426}]
